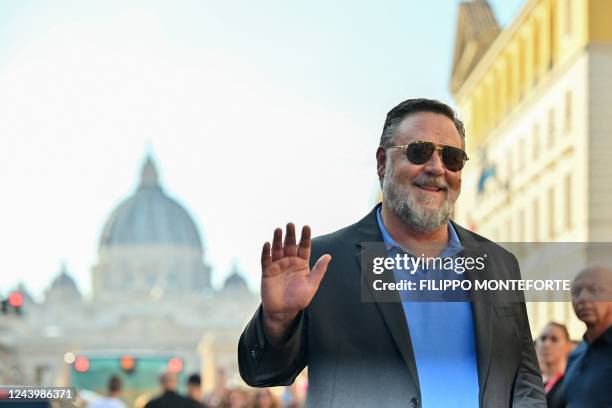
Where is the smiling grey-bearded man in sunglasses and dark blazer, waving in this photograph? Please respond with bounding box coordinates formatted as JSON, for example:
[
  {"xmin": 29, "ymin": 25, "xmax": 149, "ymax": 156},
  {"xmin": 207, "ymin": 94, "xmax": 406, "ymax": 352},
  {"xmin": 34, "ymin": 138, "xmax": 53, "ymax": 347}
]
[{"xmin": 238, "ymin": 99, "xmax": 546, "ymax": 408}]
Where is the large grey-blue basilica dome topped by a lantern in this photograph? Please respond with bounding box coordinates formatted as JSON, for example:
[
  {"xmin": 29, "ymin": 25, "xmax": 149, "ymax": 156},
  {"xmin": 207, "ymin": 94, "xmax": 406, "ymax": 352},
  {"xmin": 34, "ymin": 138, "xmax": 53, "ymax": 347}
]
[{"xmin": 100, "ymin": 157, "xmax": 202, "ymax": 250}]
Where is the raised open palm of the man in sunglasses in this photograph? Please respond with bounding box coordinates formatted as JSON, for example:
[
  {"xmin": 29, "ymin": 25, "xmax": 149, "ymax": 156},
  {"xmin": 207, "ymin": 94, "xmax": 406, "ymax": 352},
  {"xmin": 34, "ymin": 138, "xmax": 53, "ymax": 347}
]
[{"xmin": 261, "ymin": 223, "xmax": 331, "ymax": 342}]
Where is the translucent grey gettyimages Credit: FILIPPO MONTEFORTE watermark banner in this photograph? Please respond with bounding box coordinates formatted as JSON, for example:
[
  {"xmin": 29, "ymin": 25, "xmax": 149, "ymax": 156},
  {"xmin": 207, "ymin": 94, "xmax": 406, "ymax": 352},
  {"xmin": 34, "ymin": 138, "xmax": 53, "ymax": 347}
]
[{"xmin": 360, "ymin": 242, "xmax": 612, "ymax": 302}]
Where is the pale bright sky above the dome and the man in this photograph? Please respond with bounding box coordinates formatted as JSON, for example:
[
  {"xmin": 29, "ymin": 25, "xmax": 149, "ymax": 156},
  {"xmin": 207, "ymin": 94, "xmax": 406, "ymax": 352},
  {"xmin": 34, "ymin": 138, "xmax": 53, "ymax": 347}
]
[{"xmin": 0, "ymin": 0, "xmax": 523, "ymax": 299}]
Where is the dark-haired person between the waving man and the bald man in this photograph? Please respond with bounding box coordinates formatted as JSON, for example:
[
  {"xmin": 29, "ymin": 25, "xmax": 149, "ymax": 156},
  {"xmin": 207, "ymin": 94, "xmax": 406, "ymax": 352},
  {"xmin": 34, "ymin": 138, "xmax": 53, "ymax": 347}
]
[{"xmin": 536, "ymin": 322, "xmax": 572, "ymax": 408}]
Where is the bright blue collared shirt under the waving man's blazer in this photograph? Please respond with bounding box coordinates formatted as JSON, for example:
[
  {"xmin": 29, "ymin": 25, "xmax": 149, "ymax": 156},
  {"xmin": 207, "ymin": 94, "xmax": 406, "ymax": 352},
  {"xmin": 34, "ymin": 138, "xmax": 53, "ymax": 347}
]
[{"xmin": 376, "ymin": 208, "xmax": 479, "ymax": 408}]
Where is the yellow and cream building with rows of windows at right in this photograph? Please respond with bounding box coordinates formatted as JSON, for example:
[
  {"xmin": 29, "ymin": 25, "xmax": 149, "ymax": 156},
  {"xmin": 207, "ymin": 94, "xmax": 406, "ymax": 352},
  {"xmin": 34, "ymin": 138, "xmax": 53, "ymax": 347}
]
[{"xmin": 451, "ymin": 0, "xmax": 612, "ymax": 339}]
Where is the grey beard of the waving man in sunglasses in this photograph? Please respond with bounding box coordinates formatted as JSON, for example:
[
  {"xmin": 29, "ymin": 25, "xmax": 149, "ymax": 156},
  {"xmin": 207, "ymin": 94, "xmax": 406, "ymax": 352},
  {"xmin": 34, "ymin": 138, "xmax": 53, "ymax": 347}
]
[{"xmin": 383, "ymin": 163, "xmax": 457, "ymax": 232}]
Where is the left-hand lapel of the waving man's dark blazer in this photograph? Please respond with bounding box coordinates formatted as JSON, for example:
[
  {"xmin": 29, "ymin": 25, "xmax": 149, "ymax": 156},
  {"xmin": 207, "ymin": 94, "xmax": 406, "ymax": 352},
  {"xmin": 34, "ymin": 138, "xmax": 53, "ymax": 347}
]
[{"xmin": 355, "ymin": 204, "xmax": 420, "ymax": 387}]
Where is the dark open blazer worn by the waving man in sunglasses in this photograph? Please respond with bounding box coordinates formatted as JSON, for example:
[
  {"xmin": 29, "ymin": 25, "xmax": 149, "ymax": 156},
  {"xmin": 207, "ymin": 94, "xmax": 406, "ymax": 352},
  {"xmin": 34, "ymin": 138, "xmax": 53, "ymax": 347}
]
[{"xmin": 238, "ymin": 207, "xmax": 546, "ymax": 408}]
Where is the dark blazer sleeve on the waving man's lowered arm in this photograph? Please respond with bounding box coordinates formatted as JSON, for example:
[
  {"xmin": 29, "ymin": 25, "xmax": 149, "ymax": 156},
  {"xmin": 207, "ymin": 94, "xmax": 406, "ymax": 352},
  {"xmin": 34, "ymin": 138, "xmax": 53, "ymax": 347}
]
[{"xmin": 512, "ymin": 255, "xmax": 546, "ymax": 408}]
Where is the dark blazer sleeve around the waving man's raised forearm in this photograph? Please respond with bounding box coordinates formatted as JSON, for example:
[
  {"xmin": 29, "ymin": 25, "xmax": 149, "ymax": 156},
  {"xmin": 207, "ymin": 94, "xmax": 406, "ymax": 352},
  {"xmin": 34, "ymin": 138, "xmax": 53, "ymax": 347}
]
[{"xmin": 238, "ymin": 305, "xmax": 308, "ymax": 387}]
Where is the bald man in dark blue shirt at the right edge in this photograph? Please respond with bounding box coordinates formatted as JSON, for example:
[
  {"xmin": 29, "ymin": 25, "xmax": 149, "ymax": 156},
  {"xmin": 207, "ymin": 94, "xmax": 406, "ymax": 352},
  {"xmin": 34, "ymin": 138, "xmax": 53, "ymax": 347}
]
[{"xmin": 563, "ymin": 266, "xmax": 612, "ymax": 408}]
